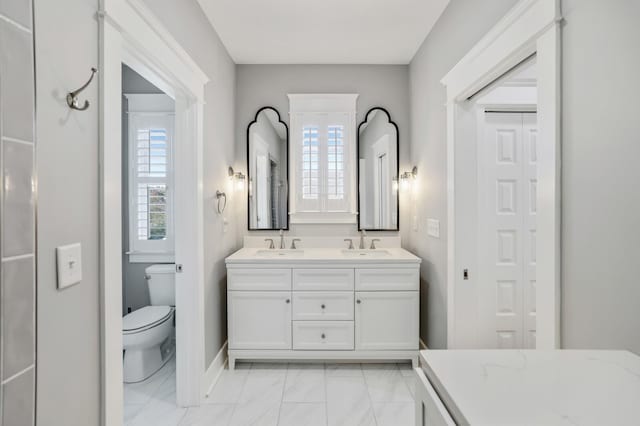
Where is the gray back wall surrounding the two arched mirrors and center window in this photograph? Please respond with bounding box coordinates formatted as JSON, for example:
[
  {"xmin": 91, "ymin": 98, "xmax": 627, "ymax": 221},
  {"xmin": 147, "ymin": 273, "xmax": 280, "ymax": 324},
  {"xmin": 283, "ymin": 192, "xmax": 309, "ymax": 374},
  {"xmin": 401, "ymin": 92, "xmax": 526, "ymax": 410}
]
[{"xmin": 235, "ymin": 65, "xmax": 411, "ymax": 241}]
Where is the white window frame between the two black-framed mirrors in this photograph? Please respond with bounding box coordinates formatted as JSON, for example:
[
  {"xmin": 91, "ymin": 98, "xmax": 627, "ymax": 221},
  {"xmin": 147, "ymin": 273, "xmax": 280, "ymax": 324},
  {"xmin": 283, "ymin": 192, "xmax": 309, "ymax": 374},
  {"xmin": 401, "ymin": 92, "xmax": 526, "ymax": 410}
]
[{"xmin": 288, "ymin": 94, "xmax": 358, "ymax": 224}]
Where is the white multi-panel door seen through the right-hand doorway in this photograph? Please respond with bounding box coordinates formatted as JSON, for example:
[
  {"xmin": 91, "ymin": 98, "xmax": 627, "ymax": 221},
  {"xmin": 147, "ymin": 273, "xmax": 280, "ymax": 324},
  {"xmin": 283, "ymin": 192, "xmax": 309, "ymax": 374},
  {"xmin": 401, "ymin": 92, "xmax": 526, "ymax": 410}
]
[{"xmin": 478, "ymin": 113, "xmax": 536, "ymax": 349}]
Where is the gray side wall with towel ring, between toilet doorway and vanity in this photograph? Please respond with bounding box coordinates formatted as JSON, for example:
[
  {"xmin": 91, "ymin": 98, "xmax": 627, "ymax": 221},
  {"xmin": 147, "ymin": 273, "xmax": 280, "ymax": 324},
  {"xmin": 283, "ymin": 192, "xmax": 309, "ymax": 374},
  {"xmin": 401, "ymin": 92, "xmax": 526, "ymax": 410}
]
[{"xmin": 145, "ymin": 0, "xmax": 241, "ymax": 368}]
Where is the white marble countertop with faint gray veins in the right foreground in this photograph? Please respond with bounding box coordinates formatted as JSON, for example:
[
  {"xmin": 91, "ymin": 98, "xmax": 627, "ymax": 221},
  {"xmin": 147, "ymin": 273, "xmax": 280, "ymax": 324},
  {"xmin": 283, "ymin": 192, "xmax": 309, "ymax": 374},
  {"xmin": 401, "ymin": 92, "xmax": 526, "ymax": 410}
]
[{"xmin": 420, "ymin": 350, "xmax": 640, "ymax": 426}]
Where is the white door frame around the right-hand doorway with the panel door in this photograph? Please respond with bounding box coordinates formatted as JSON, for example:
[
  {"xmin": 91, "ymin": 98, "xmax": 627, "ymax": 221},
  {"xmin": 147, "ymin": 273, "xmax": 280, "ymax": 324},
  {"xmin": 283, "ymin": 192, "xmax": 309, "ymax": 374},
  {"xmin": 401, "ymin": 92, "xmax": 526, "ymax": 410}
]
[{"xmin": 441, "ymin": 0, "xmax": 562, "ymax": 349}]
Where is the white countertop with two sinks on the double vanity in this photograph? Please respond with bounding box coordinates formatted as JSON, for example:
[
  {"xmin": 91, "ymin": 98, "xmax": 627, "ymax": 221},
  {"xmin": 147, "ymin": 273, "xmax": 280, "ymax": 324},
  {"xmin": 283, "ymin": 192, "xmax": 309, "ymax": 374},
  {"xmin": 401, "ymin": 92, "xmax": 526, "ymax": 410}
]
[{"xmin": 225, "ymin": 247, "xmax": 422, "ymax": 265}]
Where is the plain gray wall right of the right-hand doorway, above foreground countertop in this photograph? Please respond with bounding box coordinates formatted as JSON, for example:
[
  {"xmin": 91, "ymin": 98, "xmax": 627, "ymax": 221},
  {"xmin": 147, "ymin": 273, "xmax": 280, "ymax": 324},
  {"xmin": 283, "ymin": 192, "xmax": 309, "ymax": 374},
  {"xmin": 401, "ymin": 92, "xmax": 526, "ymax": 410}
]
[{"xmin": 562, "ymin": 0, "xmax": 640, "ymax": 354}]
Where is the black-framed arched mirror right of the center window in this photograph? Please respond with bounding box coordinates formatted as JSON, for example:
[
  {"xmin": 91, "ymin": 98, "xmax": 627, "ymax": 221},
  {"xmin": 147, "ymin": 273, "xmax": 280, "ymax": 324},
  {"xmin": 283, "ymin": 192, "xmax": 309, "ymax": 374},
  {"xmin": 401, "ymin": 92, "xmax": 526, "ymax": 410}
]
[{"xmin": 358, "ymin": 108, "xmax": 399, "ymax": 231}]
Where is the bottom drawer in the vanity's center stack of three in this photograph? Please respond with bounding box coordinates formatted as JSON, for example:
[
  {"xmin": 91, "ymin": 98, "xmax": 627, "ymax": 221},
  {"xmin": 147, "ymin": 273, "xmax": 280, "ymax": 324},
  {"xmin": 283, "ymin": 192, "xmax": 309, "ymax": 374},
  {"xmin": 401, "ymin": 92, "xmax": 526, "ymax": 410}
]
[{"xmin": 293, "ymin": 321, "xmax": 353, "ymax": 350}]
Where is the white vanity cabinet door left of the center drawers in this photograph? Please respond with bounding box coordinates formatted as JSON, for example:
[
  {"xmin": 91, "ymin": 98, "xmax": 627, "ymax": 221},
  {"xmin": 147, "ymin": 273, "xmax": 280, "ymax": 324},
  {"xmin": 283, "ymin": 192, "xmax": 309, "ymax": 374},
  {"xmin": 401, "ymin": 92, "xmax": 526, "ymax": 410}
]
[{"xmin": 228, "ymin": 291, "xmax": 291, "ymax": 349}]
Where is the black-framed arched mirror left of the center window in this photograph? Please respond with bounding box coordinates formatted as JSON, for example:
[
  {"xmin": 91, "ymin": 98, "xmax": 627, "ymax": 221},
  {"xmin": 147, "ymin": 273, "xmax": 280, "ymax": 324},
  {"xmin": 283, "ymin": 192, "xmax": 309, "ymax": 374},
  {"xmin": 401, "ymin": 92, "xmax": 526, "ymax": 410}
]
[{"xmin": 247, "ymin": 107, "xmax": 289, "ymax": 230}]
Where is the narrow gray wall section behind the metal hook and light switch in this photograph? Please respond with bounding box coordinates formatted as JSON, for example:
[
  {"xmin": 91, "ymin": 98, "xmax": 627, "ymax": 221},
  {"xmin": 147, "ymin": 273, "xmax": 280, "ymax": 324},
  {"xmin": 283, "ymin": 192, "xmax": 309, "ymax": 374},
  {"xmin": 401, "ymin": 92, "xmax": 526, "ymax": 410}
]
[{"xmin": 34, "ymin": 0, "xmax": 100, "ymax": 426}]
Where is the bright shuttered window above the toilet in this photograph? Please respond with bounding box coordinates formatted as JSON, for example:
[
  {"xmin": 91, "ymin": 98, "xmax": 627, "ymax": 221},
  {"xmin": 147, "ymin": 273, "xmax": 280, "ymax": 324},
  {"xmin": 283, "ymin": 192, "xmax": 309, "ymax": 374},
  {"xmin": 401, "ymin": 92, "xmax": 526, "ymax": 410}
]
[{"xmin": 128, "ymin": 95, "xmax": 174, "ymax": 262}]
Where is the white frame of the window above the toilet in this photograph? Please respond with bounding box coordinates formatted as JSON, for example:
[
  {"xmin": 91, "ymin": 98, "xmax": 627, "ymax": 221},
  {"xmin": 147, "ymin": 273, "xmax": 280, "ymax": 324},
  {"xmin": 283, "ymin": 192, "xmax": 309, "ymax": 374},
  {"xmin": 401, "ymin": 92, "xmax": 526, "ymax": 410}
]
[{"xmin": 125, "ymin": 94, "xmax": 175, "ymax": 263}]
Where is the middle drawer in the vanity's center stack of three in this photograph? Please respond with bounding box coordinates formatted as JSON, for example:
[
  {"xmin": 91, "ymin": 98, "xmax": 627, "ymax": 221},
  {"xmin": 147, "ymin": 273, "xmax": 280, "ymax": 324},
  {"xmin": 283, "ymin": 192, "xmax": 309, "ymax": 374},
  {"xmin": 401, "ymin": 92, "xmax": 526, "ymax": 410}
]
[{"xmin": 293, "ymin": 291, "xmax": 353, "ymax": 321}]
